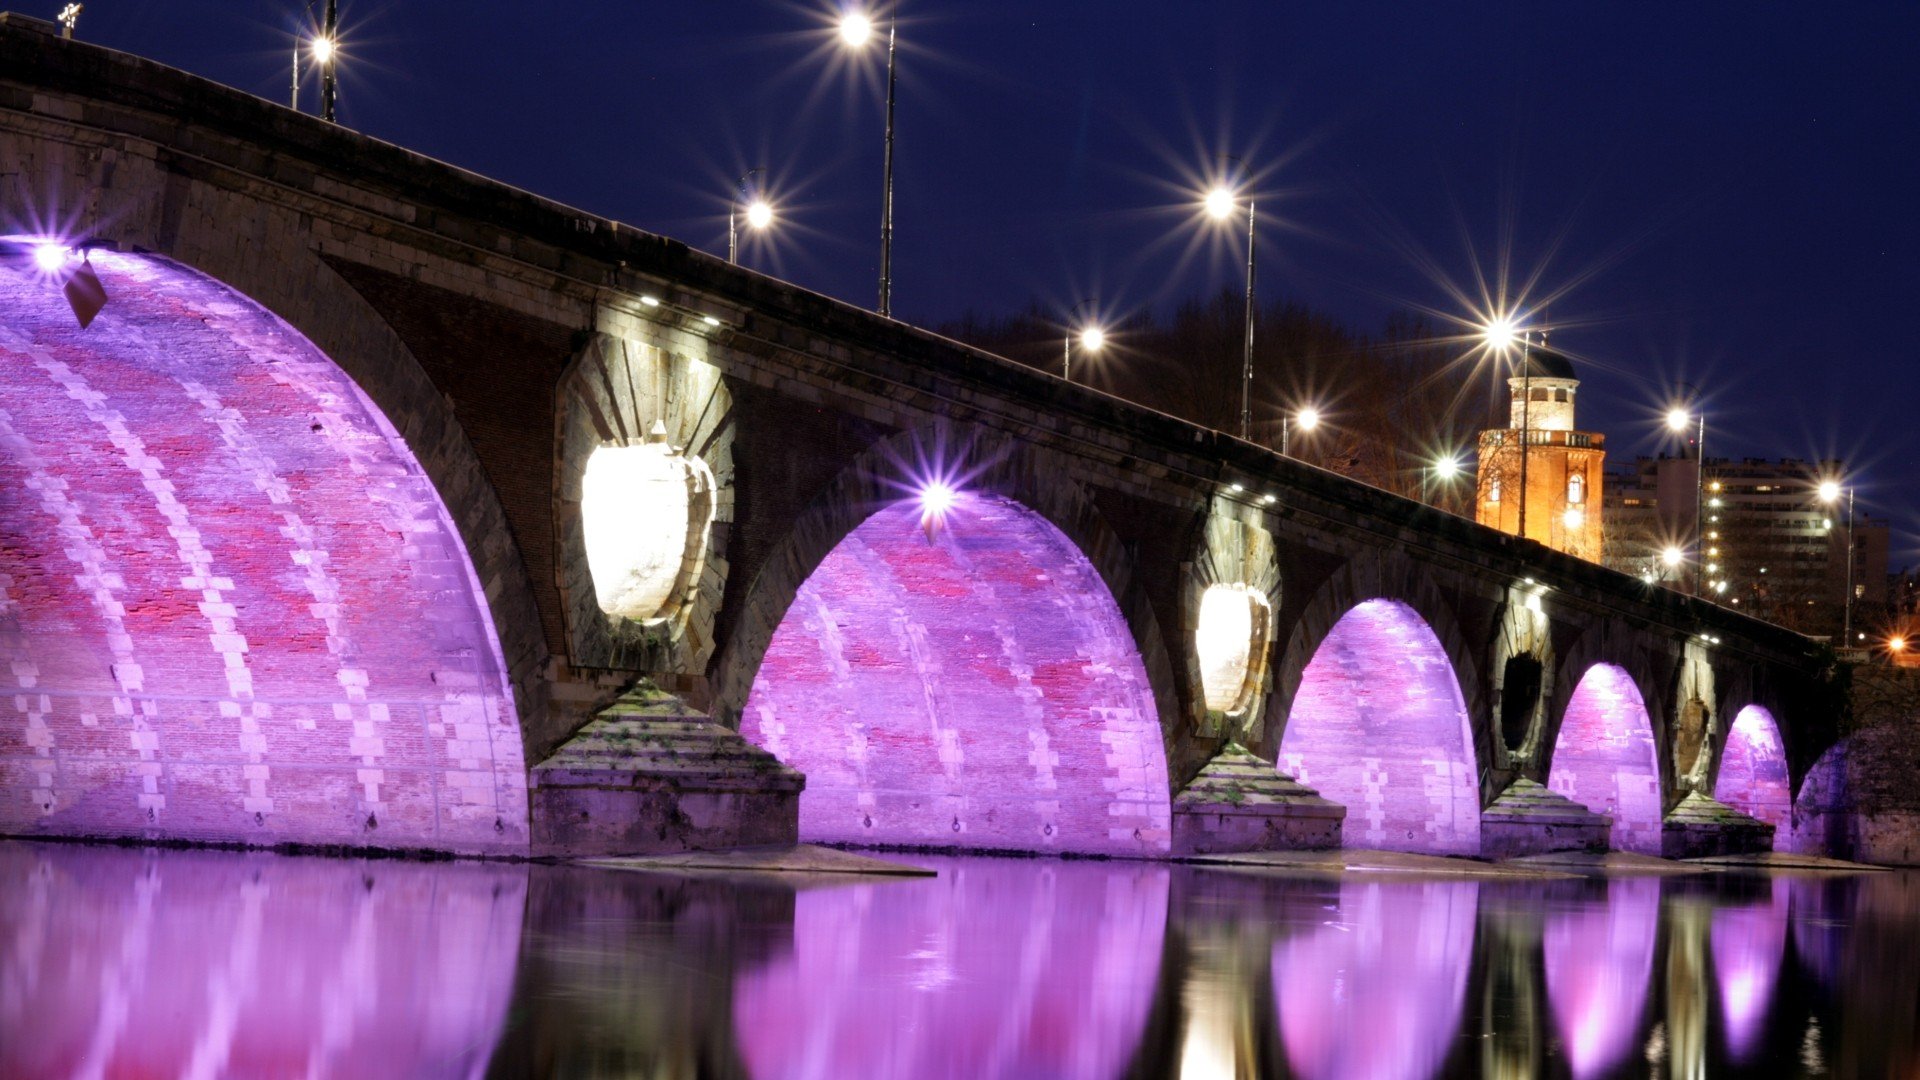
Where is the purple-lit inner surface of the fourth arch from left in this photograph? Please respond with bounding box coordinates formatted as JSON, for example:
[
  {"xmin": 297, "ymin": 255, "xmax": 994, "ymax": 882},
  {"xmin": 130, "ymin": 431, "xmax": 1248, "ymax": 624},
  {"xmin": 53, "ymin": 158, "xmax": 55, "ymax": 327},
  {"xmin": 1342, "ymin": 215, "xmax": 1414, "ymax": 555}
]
[{"xmin": 1548, "ymin": 663, "xmax": 1661, "ymax": 855}]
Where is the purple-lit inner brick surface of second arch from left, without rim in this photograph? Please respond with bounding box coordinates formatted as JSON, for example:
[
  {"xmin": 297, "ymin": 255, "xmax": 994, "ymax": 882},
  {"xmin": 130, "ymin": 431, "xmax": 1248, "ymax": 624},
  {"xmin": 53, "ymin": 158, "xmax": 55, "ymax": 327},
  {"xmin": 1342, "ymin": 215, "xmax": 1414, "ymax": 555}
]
[{"xmin": 741, "ymin": 494, "xmax": 1169, "ymax": 855}]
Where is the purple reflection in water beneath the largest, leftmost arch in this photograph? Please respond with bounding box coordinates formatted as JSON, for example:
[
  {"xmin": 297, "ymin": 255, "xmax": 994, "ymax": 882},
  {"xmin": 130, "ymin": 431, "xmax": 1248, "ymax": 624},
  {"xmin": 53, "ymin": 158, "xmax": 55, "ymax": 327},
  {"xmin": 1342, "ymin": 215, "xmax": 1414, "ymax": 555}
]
[{"xmin": 0, "ymin": 844, "xmax": 526, "ymax": 1080}]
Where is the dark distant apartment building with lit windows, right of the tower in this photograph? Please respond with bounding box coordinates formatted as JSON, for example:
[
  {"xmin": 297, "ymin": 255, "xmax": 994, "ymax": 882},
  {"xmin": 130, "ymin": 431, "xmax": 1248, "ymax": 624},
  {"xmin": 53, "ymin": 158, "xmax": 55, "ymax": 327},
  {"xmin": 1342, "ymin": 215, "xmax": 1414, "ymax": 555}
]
[{"xmin": 1605, "ymin": 454, "xmax": 1893, "ymax": 636}]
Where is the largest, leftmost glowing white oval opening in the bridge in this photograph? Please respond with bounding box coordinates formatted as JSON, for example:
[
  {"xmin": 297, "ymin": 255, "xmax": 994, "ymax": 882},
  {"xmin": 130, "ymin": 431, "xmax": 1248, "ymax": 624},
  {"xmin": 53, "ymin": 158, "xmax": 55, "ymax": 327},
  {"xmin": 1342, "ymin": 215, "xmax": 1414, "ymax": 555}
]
[{"xmin": 580, "ymin": 440, "xmax": 710, "ymax": 621}]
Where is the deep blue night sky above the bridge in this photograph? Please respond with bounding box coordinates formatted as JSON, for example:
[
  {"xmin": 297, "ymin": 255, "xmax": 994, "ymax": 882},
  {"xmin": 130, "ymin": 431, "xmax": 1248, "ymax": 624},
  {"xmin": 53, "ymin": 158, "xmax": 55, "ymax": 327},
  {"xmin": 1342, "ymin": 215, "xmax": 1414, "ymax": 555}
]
[{"xmin": 56, "ymin": 0, "xmax": 1920, "ymax": 567}]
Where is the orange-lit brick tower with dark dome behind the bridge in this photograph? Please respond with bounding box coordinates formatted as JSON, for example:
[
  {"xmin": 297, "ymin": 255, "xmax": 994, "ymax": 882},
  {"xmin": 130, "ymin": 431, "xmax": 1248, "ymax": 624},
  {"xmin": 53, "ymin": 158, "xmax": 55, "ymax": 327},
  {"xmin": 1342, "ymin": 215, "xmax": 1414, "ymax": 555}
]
[{"xmin": 1475, "ymin": 344, "xmax": 1607, "ymax": 563}]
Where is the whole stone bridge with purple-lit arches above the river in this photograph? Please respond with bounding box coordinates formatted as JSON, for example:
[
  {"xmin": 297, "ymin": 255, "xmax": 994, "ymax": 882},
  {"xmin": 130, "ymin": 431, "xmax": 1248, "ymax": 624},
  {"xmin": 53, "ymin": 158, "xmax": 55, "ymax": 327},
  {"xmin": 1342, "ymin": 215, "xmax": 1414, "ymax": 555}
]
[{"xmin": 0, "ymin": 15, "xmax": 1836, "ymax": 855}]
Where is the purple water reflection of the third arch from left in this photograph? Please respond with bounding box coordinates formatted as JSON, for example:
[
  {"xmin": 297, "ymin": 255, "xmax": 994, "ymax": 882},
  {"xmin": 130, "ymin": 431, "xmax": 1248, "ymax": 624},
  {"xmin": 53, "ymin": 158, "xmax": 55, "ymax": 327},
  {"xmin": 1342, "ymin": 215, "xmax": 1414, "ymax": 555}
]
[{"xmin": 1273, "ymin": 882, "xmax": 1480, "ymax": 1080}]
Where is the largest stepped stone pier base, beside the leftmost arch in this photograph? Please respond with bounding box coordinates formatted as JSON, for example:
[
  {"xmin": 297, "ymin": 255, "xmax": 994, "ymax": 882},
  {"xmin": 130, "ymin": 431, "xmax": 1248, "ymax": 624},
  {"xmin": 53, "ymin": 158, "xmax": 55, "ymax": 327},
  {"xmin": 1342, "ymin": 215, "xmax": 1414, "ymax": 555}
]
[{"xmin": 528, "ymin": 682, "xmax": 806, "ymax": 857}]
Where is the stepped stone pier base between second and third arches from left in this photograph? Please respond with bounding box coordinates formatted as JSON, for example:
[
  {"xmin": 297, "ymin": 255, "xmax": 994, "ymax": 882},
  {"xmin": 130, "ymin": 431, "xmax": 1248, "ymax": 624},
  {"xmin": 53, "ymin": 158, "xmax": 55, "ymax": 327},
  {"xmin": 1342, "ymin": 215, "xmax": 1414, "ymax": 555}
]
[{"xmin": 1173, "ymin": 744, "xmax": 1346, "ymax": 855}]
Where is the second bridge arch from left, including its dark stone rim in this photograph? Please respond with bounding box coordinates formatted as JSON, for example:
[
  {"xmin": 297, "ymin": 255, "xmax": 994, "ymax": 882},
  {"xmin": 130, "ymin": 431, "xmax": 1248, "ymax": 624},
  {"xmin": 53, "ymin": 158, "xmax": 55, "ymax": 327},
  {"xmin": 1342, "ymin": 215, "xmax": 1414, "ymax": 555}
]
[{"xmin": 714, "ymin": 425, "xmax": 1173, "ymax": 853}]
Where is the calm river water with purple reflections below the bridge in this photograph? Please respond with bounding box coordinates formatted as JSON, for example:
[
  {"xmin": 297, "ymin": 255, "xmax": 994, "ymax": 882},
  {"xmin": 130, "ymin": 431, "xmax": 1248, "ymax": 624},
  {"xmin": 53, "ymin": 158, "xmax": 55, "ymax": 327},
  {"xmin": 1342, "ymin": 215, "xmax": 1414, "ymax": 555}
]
[{"xmin": 0, "ymin": 844, "xmax": 1920, "ymax": 1080}]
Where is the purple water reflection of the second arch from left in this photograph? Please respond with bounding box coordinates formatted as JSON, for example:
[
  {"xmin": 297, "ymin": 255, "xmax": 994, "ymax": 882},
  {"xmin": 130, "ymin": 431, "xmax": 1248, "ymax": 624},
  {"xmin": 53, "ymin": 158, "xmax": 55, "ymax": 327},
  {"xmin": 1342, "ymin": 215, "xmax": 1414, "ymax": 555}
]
[{"xmin": 733, "ymin": 859, "xmax": 1167, "ymax": 1080}]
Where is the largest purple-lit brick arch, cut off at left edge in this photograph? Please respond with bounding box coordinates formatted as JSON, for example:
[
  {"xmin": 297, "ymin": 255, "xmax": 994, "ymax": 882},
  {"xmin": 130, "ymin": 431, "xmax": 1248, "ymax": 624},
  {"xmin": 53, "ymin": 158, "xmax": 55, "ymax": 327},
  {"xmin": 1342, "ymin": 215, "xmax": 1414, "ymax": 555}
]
[{"xmin": 0, "ymin": 252, "xmax": 526, "ymax": 851}]
